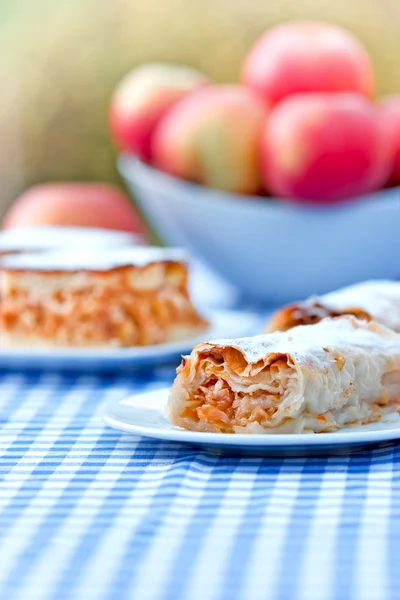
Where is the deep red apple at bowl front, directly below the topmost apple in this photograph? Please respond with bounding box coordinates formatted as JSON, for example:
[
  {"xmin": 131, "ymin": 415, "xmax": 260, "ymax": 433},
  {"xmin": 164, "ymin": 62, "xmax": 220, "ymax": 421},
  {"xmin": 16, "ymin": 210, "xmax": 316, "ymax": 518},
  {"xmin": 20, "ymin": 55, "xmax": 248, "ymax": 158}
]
[{"xmin": 262, "ymin": 93, "xmax": 392, "ymax": 202}]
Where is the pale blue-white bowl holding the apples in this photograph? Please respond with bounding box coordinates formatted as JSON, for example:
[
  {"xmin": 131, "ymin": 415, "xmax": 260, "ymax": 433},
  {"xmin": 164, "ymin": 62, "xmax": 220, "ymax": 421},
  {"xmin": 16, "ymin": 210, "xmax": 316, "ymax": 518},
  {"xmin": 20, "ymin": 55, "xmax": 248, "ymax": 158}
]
[{"xmin": 118, "ymin": 155, "xmax": 400, "ymax": 304}]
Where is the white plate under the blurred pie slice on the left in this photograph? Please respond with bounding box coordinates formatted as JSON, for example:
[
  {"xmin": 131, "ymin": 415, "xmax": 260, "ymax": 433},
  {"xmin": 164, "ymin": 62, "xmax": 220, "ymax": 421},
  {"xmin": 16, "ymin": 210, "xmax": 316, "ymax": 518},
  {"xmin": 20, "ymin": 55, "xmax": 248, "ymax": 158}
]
[{"xmin": 0, "ymin": 310, "xmax": 263, "ymax": 372}]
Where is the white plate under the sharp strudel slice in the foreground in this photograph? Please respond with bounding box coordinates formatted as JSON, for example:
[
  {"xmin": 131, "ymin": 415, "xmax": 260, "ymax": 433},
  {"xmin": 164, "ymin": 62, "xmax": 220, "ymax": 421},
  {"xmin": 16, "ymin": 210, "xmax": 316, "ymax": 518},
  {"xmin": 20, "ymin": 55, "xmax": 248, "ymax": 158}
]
[{"xmin": 103, "ymin": 388, "xmax": 400, "ymax": 456}]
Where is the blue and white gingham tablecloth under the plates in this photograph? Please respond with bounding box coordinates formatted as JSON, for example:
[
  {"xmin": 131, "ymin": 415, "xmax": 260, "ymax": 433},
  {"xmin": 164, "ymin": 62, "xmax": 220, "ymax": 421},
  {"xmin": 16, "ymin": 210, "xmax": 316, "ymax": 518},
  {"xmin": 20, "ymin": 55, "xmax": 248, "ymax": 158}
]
[{"xmin": 0, "ymin": 368, "xmax": 400, "ymax": 600}]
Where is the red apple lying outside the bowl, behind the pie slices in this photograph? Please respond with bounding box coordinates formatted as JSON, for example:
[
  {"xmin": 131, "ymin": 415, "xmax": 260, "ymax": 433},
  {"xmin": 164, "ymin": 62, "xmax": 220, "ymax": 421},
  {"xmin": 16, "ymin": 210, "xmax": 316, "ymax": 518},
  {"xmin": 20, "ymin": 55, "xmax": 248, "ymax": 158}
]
[{"xmin": 3, "ymin": 183, "xmax": 145, "ymax": 233}]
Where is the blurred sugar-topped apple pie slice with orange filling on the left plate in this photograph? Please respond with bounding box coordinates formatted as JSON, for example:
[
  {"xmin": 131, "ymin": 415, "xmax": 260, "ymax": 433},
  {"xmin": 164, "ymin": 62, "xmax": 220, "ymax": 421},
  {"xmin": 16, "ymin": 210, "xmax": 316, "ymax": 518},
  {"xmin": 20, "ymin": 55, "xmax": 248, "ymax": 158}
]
[{"xmin": 0, "ymin": 247, "xmax": 208, "ymax": 347}]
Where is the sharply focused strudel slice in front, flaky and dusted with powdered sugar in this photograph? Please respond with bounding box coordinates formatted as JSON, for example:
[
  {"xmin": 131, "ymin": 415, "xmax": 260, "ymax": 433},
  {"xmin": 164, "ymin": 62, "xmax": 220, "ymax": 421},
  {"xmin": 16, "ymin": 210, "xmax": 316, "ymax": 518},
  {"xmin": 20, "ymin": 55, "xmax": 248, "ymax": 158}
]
[{"xmin": 168, "ymin": 317, "xmax": 400, "ymax": 434}]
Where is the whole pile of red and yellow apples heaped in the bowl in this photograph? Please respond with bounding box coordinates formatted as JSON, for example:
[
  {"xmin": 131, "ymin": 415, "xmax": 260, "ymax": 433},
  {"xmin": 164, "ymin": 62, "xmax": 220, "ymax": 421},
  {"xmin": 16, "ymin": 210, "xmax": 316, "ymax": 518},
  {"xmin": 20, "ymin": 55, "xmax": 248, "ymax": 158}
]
[{"xmin": 110, "ymin": 22, "xmax": 400, "ymax": 203}]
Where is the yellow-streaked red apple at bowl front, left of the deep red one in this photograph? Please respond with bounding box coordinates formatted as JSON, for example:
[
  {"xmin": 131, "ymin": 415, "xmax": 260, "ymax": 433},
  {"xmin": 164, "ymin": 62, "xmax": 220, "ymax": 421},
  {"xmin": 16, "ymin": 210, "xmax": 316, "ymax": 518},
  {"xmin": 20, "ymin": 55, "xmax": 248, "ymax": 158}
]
[{"xmin": 153, "ymin": 85, "xmax": 267, "ymax": 194}]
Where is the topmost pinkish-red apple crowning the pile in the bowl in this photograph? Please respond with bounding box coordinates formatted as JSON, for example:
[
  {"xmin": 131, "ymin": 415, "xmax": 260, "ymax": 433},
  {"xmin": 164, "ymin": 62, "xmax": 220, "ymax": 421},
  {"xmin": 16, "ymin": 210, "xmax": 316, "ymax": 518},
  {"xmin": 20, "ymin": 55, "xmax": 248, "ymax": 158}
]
[{"xmin": 242, "ymin": 21, "xmax": 374, "ymax": 104}]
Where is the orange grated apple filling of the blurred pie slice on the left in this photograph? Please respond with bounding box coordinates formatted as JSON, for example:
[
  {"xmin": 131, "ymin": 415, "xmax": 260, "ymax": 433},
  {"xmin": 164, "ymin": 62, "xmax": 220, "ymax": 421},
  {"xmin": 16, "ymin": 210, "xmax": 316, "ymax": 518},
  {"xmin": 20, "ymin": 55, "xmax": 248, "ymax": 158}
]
[{"xmin": 0, "ymin": 267, "xmax": 207, "ymax": 346}]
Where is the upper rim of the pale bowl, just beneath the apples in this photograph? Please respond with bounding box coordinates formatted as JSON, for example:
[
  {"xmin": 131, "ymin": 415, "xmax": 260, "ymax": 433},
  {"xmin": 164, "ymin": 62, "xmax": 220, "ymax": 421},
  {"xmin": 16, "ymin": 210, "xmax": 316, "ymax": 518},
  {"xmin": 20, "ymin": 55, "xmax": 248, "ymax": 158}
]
[{"xmin": 117, "ymin": 152, "xmax": 400, "ymax": 215}]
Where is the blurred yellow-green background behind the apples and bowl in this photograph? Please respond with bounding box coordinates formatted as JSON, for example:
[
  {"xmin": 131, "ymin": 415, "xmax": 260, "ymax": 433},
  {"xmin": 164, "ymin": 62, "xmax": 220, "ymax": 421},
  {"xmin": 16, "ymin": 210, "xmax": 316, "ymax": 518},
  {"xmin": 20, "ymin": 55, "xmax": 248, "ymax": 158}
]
[{"xmin": 0, "ymin": 0, "xmax": 400, "ymax": 216}]
